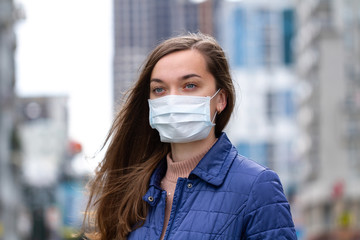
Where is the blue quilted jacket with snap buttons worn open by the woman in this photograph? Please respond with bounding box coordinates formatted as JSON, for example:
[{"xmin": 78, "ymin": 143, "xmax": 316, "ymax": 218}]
[{"xmin": 128, "ymin": 133, "xmax": 296, "ymax": 240}]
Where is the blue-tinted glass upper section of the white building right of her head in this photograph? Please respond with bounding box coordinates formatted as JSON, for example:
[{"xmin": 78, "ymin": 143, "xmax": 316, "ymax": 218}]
[{"xmin": 231, "ymin": 6, "xmax": 295, "ymax": 68}]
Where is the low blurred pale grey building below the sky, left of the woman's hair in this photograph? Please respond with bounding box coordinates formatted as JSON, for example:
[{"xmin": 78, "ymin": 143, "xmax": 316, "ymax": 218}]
[{"xmin": 16, "ymin": 96, "xmax": 84, "ymax": 240}]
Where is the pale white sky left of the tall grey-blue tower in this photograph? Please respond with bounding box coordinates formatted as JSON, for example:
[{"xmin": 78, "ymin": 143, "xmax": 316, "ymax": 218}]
[{"xmin": 16, "ymin": 0, "xmax": 112, "ymax": 165}]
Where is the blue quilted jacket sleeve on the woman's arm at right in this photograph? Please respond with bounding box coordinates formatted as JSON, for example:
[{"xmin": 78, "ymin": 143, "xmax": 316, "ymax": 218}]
[{"xmin": 243, "ymin": 170, "xmax": 297, "ymax": 240}]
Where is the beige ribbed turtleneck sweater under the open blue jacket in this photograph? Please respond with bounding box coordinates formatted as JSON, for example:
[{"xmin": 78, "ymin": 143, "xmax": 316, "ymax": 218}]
[{"xmin": 160, "ymin": 139, "xmax": 217, "ymax": 240}]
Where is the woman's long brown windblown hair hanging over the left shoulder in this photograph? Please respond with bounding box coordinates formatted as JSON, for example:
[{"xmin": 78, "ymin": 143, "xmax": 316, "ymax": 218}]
[{"xmin": 84, "ymin": 33, "xmax": 235, "ymax": 240}]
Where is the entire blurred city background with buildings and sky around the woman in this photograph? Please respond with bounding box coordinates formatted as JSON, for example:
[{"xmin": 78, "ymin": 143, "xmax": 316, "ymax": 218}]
[{"xmin": 0, "ymin": 0, "xmax": 360, "ymax": 240}]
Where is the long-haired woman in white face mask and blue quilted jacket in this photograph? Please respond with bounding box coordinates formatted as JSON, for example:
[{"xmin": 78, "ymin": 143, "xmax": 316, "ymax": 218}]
[{"xmin": 86, "ymin": 34, "xmax": 296, "ymax": 240}]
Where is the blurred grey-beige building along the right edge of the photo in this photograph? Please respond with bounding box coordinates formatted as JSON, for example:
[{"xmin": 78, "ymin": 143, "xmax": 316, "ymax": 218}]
[{"xmin": 296, "ymin": 0, "xmax": 360, "ymax": 239}]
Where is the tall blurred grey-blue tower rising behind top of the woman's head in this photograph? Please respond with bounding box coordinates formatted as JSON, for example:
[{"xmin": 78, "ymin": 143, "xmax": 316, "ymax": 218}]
[{"xmin": 113, "ymin": 0, "xmax": 214, "ymax": 106}]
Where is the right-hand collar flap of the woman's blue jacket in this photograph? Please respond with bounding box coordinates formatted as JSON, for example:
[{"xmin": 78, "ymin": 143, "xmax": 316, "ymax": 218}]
[{"xmin": 189, "ymin": 133, "xmax": 237, "ymax": 186}]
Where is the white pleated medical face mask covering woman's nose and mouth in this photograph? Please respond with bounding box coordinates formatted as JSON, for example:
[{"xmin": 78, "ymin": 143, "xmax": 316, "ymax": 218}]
[{"xmin": 148, "ymin": 89, "xmax": 220, "ymax": 143}]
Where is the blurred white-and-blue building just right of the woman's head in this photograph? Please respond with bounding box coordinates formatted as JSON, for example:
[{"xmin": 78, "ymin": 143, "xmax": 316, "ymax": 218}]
[{"xmin": 216, "ymin": 0, "xmax": 298, "ymax": 204}]
